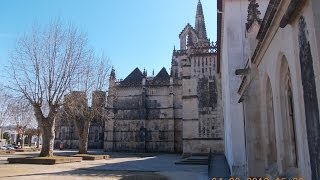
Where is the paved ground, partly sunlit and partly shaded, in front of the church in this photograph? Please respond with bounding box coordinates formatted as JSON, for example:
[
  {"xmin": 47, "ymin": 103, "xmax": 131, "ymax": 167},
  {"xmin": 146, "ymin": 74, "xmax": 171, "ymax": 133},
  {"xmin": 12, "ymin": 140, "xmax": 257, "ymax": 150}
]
[{"xmin": 0, "ymin": 151, "xmax": 208, "ymax": 180}]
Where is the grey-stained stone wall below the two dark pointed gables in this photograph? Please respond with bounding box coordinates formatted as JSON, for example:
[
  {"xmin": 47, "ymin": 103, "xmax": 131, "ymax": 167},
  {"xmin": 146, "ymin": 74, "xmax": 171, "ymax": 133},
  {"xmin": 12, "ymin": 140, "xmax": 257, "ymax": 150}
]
[{"xmin": 106, "ymin": 86, "xmax": 176, "ymax": 152}]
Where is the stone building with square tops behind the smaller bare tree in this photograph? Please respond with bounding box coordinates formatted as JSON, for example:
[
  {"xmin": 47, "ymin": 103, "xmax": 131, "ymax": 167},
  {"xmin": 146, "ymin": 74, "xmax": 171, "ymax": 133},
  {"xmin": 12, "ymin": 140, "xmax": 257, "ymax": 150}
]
[{"xmin": 54, "ymin": 91, "xmax": 106, "ymax": 149}]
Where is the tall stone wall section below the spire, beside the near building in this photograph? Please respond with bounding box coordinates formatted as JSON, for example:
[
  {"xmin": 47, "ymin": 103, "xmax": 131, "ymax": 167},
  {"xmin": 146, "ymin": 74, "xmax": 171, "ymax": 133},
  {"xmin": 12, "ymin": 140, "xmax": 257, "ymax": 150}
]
[{"xmin": 179, "ymin": 49, "xmax": 224, "ymax": 154}]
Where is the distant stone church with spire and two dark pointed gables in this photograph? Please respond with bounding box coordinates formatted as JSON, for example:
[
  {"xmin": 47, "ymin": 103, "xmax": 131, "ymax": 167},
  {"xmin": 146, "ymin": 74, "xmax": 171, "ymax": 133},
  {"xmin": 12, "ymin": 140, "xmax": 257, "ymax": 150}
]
[{"xmin": 104, "ymin": 1, "xmax": 224, "ymax": 154}]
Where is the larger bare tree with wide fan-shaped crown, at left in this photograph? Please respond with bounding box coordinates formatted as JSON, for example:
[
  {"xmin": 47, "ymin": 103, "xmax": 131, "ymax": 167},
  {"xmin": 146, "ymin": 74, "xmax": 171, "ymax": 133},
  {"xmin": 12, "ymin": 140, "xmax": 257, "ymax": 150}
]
[{"xmin": 9, "ymin": 21, "xmax": 91, "ymax": 156}]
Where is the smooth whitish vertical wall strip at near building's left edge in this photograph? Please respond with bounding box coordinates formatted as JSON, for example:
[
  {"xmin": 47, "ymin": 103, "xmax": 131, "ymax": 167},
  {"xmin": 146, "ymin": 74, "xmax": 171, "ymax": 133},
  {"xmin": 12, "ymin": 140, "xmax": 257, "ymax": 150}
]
[{"xmin": 221, "ymin": 0, "xmax": 248, "ymax": 177}]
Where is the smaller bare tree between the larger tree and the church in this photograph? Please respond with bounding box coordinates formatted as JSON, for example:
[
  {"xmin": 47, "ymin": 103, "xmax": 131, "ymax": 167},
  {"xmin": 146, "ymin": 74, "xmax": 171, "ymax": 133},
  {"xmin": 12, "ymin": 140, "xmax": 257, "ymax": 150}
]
[{"xmin": 63, "ymin": 57, "xmax": 110, "ymax": 154}]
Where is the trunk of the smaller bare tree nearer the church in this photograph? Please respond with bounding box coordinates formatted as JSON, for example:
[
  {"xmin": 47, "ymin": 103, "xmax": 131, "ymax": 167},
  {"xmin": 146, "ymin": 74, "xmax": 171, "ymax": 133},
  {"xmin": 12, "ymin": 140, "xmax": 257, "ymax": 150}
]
[{"xmin": 76, "ymin": 121, "xmax": 90, "ymax": 154}]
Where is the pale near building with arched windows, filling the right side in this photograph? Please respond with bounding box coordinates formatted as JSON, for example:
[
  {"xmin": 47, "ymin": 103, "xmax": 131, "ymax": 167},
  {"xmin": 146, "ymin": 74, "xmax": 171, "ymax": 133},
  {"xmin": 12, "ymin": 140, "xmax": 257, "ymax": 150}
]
[{"xmin": 218, "ymin": 0, "xmax": 320, "ymax": 180}]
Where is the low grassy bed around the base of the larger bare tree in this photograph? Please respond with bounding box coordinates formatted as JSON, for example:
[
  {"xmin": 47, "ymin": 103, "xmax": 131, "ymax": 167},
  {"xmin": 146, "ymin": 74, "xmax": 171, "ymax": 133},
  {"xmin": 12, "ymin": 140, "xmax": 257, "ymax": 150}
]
[{"xmin": 7, "ymin": 156, "xmax": 82, "ymax": 165}]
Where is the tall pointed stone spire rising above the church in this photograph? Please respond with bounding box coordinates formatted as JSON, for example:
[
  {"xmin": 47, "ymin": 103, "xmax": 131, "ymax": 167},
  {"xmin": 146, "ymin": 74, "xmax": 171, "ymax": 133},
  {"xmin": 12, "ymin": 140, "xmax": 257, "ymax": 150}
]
[{"xmin": 195, "ymin": 0, "xmax": 207, "ymax": 40}]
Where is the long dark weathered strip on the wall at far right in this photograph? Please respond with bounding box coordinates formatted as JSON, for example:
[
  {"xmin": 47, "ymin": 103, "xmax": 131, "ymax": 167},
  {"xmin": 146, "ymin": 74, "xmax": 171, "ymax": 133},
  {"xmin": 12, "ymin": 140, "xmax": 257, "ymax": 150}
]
[{"xmin": 299, "ymin": 17, "xmax": 320, "ymax": 179}]
